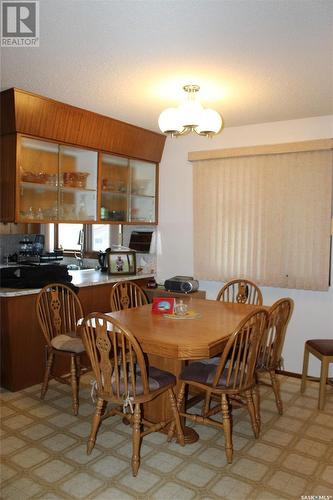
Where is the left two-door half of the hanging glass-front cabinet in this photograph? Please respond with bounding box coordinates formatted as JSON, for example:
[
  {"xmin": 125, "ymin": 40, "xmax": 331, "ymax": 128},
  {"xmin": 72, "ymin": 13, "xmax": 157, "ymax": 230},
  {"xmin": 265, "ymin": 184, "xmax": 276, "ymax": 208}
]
[{"xmin": 15, "ymin": 135, "xmax": 98, "ymax": 223}]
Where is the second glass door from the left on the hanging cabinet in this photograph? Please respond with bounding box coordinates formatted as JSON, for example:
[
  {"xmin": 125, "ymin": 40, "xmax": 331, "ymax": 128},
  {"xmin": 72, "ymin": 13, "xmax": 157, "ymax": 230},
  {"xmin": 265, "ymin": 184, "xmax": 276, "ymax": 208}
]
[{"xmin": 58, "ymin": 146, "xmax": 97, "ymax": 222}]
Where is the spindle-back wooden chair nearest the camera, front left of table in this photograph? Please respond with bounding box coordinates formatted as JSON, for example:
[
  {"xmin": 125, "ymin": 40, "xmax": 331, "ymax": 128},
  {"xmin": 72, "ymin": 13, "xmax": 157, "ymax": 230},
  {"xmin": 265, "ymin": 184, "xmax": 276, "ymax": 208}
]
[{"xmin": 82, "ymin": 313, "xmax": 184, "ymax": 476}]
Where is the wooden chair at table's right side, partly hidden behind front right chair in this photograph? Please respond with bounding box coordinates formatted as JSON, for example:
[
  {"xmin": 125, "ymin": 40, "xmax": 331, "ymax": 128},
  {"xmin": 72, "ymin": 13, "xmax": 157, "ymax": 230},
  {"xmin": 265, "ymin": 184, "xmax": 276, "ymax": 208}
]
[{"xmin": 256, "ymin": 298, "xmax": 294, "ymax": 418}]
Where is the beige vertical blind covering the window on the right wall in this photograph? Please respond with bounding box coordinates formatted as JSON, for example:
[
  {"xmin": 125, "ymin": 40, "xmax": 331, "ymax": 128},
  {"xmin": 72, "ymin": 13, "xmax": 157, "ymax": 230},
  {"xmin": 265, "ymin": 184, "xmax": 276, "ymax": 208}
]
[{"xmin": 193, "ymin": 146, "xmax": 332, "ymax": 290}]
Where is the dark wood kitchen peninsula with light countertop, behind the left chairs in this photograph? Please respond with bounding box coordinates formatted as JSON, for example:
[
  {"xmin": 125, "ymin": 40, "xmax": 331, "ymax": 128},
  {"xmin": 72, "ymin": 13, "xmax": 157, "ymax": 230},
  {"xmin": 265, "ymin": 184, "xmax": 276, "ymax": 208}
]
[{"xmin": 0, "ymin": 269, "xmax": 153, "ymax": 391}]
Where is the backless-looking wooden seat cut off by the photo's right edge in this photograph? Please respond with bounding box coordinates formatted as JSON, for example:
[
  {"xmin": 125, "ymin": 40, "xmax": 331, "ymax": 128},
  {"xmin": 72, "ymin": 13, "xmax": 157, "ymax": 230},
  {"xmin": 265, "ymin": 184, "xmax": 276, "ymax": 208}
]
[{"xmin": 301, "ymin": 339, "xmax": 333, "ymax": 410}]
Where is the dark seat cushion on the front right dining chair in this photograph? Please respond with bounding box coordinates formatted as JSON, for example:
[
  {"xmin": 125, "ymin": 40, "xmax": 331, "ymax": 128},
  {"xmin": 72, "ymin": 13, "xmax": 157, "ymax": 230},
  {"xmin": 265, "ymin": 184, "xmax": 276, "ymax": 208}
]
[{"xmin": 180, "ymin": 358, "xmax": 233, "ymax": 388}]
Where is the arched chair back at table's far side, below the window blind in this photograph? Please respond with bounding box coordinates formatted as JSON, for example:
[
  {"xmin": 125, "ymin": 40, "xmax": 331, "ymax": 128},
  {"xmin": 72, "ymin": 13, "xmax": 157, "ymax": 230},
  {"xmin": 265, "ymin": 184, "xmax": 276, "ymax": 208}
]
[{"xmin": 216, "ymin": 279, "xmax": 262, "ymax": 306}]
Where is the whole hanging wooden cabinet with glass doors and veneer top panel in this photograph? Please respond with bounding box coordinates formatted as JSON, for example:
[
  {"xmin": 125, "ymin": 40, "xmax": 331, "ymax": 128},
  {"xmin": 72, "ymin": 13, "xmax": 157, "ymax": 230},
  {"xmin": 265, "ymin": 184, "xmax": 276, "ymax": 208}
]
[{"xmin": 0, "ymin": 89, "xmax": 165, "ymax": 224}]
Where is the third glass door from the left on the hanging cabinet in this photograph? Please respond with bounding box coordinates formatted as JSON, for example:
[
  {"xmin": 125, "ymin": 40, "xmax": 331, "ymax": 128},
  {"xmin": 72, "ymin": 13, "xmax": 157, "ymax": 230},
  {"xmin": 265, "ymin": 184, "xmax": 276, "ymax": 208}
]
[{"xmin": 100, "ymin": 154, "xmax": 130, "ymax": 222}]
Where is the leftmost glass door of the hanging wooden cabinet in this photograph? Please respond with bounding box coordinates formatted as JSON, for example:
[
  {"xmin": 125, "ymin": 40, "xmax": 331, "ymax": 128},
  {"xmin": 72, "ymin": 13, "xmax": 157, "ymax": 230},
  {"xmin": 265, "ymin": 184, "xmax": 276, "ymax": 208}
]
[{"xmin": 17, "ymin": 137, "xmax": 59, "ymax": 222}]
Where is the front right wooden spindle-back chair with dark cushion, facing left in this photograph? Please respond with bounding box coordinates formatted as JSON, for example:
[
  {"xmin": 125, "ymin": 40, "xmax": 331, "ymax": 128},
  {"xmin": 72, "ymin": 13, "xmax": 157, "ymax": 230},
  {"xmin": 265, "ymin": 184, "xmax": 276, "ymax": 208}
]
[{"xmin": 170, "ymin": 308, "xmax": 268, "ymax": 463}]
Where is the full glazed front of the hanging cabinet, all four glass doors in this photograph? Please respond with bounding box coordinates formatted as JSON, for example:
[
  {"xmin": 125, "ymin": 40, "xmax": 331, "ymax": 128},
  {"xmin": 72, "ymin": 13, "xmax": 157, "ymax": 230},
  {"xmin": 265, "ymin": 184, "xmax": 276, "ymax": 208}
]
[{"xmin": 16, "ymin": 136, "xmax": 157, "ymax": 224}]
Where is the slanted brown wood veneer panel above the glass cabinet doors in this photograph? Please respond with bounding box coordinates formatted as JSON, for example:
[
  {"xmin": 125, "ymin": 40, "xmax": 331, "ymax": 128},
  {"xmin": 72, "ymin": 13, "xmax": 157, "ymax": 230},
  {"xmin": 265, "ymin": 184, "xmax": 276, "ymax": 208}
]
[{"xmin": 2, "ymin": 88, "xmax": 166, "ymax": 163}]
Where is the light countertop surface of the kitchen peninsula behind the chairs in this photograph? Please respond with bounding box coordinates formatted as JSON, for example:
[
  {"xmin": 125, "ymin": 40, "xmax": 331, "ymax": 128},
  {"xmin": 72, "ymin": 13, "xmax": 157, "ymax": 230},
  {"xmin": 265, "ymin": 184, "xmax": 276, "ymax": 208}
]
[{"xmin": 0, "ymin": 269, "xmax": 154, "ymax": 297}]
